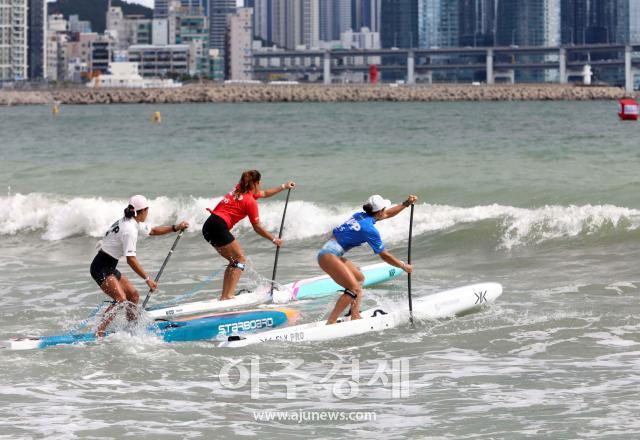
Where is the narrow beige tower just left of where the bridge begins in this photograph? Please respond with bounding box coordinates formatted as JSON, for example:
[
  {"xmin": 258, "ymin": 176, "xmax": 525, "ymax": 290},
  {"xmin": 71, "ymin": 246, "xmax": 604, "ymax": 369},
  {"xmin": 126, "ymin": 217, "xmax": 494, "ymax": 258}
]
[{"xmin": 225, "ymin": 8, "xmax": 253, "ymax": 81}]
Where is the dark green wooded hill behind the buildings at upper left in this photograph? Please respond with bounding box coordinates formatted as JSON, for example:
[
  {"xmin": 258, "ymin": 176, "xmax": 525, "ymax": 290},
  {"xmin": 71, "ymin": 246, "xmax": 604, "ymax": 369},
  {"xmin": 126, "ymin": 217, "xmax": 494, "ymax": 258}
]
[{"xmin": 48, "ymin": 0, "xmax": 153, "ymax": 33}]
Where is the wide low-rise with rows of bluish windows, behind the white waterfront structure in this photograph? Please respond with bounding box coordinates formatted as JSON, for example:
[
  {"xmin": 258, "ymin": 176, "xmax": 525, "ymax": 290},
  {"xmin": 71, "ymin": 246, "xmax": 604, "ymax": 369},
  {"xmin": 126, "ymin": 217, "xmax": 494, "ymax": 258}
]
[{"xmin": 129, "ymin": 44, "xmax": 196, "ymax": 78}]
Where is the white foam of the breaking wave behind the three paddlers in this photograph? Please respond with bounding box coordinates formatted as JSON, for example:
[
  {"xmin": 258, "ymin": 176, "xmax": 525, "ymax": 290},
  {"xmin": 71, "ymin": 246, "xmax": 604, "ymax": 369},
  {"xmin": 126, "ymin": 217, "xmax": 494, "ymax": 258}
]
[{"xmin": 0, "ymin": 193, "xmax": 640, "ymax": 249}]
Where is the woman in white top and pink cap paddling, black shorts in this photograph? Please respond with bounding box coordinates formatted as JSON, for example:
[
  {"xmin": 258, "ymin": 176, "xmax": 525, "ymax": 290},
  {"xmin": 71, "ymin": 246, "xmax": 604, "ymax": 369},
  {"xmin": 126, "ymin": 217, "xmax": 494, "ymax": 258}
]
[{"xmin": 91, "ymin": 195, "xmax": 189, "ymax": 337}]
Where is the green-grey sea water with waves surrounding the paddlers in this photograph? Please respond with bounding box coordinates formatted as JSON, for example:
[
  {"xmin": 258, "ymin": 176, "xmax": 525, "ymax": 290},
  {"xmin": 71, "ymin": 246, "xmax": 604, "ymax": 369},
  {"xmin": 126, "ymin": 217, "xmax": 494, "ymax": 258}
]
[{"xmin": 0, "ymin": 102, "xmax": 640, "ymax": 439}]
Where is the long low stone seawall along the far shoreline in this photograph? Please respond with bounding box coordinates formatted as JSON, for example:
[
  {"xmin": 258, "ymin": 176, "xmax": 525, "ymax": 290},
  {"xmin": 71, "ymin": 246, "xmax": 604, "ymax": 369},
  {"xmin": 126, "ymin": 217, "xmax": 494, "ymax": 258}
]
[{"xmin": 0, "ymin": 84, "xmax": 625, "ymax": 106}]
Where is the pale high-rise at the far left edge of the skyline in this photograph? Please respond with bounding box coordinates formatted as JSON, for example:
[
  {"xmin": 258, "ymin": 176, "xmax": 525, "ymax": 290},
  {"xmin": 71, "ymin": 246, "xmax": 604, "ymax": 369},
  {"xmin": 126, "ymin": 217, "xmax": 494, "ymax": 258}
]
[{"xmin": 0, "ymin": 0, "xmax": 28, "ymax": 82}]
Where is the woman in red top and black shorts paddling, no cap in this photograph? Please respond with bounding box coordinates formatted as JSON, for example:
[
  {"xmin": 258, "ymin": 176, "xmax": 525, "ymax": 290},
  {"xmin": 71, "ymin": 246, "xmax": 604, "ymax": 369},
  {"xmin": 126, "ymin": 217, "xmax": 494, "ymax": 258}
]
[{"xmin": 202, "ymin": 170, "xmax": 295, "ymax": 300}]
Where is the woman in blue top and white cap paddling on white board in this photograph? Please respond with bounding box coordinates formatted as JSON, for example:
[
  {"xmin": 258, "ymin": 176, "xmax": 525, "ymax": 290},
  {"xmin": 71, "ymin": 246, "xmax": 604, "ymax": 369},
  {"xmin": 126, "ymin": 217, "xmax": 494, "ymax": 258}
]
[{"xmin": 318, "ymin": 194, "xmax": 418, "ymax": 324}]
